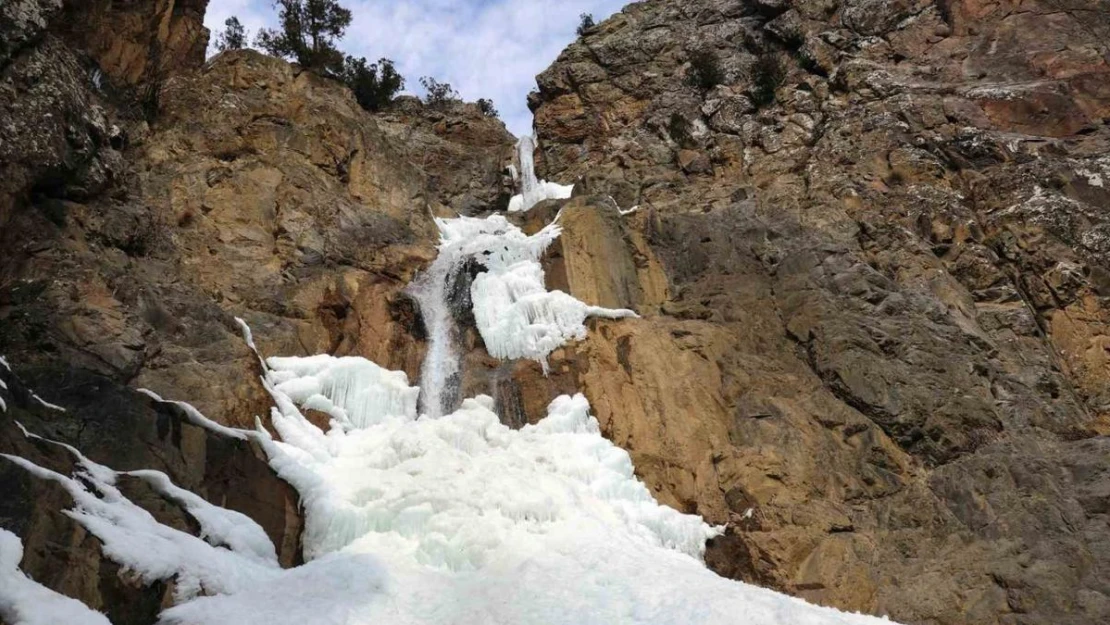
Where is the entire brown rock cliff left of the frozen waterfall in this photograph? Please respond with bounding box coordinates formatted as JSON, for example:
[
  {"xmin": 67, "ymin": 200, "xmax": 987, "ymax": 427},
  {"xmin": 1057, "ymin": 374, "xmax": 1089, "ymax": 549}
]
[{"xmin": 0, "ymin": 0, "xmax": 512, "ymax": 624}]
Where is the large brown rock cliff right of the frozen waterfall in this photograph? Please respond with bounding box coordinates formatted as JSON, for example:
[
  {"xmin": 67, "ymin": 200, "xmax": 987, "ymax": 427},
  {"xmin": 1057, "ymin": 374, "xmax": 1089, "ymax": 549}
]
[{"xmin": 519, "ymin": 0, "xmax": 1110, "ymax": 624}]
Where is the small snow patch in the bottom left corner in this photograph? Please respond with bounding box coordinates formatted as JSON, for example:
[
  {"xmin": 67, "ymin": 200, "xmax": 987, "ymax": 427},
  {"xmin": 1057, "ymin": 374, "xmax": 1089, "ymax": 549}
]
[{"xmin": 0, "ymin": 527, "xmax": 111, "ymax": 625}]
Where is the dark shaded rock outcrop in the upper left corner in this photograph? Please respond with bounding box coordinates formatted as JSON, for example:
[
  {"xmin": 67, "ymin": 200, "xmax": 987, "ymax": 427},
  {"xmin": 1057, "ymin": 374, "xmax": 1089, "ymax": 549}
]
[{"xmin": 0, "ymin": 0, "xmax": 209, "ymax": 226}]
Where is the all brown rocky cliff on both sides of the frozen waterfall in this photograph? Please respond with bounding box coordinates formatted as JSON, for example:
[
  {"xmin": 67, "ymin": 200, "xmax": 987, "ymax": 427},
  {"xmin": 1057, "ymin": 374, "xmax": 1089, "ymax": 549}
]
[{"xmin": 0, "ymin": 0, "xmax": 1110, "ymax": 624}]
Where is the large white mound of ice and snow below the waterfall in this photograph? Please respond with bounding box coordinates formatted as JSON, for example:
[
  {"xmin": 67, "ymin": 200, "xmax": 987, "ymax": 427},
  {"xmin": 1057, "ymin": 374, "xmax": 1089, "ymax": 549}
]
[{"xmin": 162, "ymin": 359, "xmax": 886, "ymax": 625}]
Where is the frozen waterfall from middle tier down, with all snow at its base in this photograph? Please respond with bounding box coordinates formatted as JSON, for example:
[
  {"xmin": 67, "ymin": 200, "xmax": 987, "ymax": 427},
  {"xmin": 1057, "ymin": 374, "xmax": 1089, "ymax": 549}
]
[{"xmin": 0, "ymin": 183, "xmax": 889, "ymax": 625}]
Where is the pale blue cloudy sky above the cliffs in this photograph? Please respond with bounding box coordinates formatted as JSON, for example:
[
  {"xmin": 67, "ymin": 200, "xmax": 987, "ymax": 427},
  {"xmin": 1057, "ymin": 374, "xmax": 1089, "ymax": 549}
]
[{"xmin": 204, "ymin": 0, "xmax": 629, "ymax": 135}]
